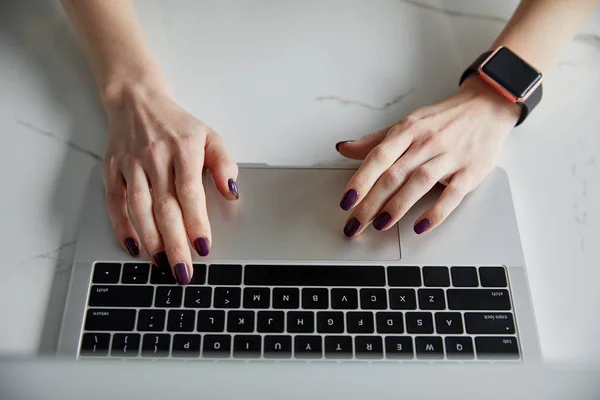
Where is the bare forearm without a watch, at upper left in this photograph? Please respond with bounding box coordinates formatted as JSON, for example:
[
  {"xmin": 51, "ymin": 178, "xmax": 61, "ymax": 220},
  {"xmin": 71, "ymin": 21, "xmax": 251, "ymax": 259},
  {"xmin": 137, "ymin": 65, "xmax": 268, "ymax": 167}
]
[{"xmin": 62, "ymin": 0, "xmax": 168, "ymax": 103}]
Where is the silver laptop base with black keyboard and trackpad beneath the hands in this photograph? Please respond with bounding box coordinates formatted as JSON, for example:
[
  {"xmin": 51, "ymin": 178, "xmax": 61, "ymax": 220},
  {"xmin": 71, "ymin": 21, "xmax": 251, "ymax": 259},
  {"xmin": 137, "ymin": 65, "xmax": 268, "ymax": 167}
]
[{"xmin": 58, "ymin": 165, "xmax": 541, "ymax": 363}]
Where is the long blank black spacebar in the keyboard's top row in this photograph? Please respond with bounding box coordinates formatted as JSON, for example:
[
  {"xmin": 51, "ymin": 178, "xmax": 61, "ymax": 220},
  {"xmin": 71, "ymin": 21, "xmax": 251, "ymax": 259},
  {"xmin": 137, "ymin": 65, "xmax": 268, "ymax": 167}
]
[{"xmin": 244, "ymin": 265, "xmax": 385, "ymax": 286}]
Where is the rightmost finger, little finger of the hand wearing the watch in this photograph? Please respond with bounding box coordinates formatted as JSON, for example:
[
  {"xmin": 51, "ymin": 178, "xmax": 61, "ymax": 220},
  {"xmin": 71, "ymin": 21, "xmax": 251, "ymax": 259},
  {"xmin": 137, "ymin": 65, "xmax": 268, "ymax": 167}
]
[{"xmin": 414, "ymin": 171, "xmax": 474, "ymax": 234}]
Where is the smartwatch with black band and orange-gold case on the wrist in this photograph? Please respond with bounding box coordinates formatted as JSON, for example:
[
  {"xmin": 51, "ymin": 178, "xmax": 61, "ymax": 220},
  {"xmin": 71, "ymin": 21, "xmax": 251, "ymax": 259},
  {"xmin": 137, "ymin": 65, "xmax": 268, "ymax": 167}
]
[{"xmin": 460, "ymin": 46, "xmax": 543, "ymax": 126}]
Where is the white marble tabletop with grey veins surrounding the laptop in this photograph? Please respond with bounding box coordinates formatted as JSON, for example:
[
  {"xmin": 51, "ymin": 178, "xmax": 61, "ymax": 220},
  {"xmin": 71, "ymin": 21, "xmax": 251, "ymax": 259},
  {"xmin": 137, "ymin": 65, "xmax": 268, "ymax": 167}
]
[{"xmin": 0, "ymin": 0, "xmax": 600, "ymax": 359}]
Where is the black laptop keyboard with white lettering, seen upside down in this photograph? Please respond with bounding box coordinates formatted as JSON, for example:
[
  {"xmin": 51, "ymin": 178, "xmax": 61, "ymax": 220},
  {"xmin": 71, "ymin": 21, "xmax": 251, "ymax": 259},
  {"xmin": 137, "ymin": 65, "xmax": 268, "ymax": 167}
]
[{"xmin": 80, "ymin": 263, "xmax": 520, "ymax": 361}]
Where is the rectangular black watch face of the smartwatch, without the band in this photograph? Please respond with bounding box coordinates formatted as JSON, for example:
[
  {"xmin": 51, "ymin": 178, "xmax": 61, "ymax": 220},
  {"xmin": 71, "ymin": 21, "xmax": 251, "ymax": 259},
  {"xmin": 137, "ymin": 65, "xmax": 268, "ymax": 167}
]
[{"xmin": 481, "ymin": 47, "xmax": 542, "ymax": 98}]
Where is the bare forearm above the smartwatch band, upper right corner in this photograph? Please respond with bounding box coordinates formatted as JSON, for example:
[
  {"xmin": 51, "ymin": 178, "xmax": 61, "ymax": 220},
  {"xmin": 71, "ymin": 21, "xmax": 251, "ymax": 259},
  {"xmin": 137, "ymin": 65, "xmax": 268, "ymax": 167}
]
[{"xmin": 492, "ymin": 0, "xmax": 597, "ymax": 72}]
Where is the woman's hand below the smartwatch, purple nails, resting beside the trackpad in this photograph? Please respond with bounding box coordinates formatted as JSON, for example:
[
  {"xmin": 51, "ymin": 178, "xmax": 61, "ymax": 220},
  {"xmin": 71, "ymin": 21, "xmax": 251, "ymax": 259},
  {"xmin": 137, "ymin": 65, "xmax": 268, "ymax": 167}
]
[{"xmin": 336, "ymin": 76, "xmax": 521, "ymax": 237}]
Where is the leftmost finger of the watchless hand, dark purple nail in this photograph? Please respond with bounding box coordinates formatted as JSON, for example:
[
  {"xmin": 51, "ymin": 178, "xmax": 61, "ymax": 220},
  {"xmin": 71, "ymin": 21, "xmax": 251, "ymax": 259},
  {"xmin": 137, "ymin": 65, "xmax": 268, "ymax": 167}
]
[{"xmin": 102, "ymin": 163, "xmax": 140, "ymax": 257}]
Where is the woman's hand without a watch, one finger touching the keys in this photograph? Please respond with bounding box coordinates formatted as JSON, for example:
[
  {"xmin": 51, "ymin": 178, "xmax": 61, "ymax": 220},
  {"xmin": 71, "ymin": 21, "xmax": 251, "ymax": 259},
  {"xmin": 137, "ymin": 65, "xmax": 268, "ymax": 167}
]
[{"xmin": 102, "ymin": 85, "xmax": 239, "ymax": 284}]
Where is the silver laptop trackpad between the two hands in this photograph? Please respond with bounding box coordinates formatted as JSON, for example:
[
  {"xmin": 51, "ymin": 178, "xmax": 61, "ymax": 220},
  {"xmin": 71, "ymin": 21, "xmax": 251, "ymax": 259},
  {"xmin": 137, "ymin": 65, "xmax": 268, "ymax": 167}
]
[{"xmin": 206, "ymin": 168, "xmax": 400, "ymax": 261}]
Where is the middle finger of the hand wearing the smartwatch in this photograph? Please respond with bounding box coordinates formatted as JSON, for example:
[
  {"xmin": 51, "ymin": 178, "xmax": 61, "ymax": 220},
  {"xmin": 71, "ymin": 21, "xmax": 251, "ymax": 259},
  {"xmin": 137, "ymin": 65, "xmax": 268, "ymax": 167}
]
[{"xmin": 348, "ymin": 148, "xmax": 438, "ymax": 236}]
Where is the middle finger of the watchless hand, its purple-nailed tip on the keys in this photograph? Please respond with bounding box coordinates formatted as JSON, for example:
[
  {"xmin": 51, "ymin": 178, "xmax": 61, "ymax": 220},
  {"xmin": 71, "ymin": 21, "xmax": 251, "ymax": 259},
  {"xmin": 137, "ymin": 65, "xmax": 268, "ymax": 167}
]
[{"xmin": 147, "ymin": 160, "xmax": 193, "ymax": 285}]
